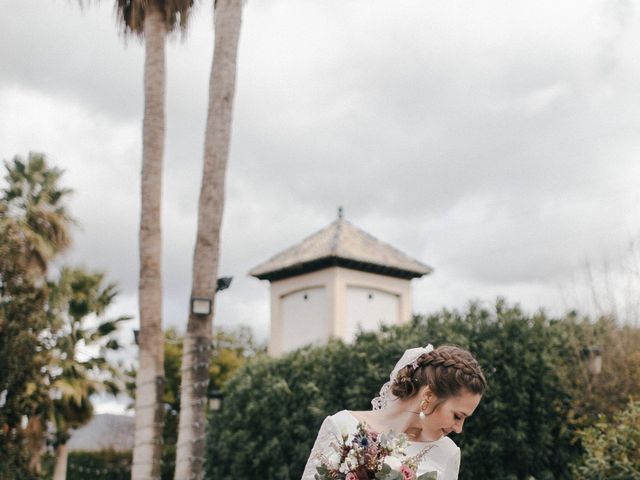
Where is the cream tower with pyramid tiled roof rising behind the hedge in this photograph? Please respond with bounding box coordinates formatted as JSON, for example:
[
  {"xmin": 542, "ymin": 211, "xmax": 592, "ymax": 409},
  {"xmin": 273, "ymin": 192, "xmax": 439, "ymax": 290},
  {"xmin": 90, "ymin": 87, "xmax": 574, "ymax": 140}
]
[{"xmin": 249, "ymin": 209, "xmax": 432, "ymax": 355}]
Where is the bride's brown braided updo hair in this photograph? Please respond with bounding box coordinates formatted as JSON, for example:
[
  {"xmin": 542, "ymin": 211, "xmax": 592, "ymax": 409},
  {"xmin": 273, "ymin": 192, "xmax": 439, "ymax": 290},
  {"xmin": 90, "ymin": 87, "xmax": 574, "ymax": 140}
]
[{"xmin": 391, "ymin": 345, "xmax": 487, "ymax": 401}]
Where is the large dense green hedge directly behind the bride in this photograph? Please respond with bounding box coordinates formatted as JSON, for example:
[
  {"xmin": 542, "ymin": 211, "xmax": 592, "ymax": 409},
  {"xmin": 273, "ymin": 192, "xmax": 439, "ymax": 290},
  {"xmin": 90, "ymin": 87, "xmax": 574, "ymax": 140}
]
[{"xmin": 206, "ymin": 300, "xmax": 579, "ymax": 480}]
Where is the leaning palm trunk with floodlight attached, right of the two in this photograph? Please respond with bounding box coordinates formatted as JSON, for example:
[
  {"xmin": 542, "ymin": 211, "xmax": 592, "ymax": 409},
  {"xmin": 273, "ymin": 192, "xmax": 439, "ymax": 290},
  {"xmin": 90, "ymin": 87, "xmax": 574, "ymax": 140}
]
[{"xmin": 174, "ymin": 0, "xmax": 242, "ymax": 480}]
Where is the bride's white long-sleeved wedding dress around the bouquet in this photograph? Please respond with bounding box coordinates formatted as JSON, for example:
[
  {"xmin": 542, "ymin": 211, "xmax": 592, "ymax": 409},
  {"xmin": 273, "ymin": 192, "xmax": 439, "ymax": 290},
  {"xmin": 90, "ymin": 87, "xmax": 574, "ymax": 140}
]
[{"xmin": 301, "ymin": 410, "xmax": 460, "ymax": 480}]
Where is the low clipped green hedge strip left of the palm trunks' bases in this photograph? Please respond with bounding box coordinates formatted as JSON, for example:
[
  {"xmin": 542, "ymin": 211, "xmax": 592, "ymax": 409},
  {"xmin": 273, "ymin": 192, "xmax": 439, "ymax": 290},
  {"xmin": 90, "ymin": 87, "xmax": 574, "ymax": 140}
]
[{"xmin": 67, "ymin": 450, "xmax": 131, "ymax": 480}]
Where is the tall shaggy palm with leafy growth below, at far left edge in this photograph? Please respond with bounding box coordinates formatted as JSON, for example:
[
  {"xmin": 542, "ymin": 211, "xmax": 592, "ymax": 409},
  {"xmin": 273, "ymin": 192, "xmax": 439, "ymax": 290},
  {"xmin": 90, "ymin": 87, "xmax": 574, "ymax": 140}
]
[{"xmin": 0, "ymin": 153, "xmax": 72, "ymax": 478}]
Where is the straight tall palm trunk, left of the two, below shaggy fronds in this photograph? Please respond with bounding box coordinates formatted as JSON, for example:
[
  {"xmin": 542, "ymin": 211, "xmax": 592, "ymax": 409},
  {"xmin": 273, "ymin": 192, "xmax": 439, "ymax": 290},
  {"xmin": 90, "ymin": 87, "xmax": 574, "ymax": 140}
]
[{"xmin": 131, "ymin": 2, "xmax": 166, "ymax": 480}]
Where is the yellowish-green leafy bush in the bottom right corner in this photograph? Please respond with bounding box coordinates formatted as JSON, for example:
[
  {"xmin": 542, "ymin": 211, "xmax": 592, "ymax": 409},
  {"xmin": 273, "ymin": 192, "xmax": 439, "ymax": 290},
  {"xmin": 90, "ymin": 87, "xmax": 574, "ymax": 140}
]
[{"xmin": 574, "ymin": 401, "xmax": 640, "ymax": 480}]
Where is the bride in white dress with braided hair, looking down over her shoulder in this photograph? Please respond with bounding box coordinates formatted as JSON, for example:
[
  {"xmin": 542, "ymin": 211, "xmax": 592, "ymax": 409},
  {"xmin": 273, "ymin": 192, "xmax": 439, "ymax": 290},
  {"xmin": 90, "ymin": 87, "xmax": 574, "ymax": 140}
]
[{"xmin": 302, "ymin": 345, "xmax": 487, "ymax": 480}]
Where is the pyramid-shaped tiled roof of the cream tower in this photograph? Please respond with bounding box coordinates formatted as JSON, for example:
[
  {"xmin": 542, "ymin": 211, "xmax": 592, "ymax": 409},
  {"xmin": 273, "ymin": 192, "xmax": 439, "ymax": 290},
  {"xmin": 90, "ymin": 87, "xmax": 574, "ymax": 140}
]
[{"xmin": 249, "ymin": 217, "xmax": 432, "ymax": 280}]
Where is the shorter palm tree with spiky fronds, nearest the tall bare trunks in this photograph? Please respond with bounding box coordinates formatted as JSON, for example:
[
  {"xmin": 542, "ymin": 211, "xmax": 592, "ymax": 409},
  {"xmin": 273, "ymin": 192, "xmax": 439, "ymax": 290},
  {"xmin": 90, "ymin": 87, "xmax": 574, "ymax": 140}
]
[{"xmin": 41, "ymin": 268, "xmax": 131, "ymax": 480}]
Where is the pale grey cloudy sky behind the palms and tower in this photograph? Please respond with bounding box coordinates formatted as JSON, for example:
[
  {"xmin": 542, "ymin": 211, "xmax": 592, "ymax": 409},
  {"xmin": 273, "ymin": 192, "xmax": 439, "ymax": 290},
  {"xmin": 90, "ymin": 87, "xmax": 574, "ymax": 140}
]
[{"xmin": 0, "ymin": 0, "xmax": 640, "ymax": 382}]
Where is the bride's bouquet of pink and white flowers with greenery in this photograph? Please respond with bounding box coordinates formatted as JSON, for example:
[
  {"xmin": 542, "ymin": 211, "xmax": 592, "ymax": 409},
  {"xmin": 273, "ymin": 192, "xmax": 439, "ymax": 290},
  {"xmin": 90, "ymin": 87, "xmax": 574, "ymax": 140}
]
[{"xmin": 315, "ymin": 422, "xmax": 437, "ymax": 480}]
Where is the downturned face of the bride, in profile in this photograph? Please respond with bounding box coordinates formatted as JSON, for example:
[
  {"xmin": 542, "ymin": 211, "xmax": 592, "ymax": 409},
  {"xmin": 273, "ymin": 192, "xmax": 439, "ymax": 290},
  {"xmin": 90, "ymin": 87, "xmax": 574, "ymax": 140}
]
[{"xmin": 423, "ymin": 390, "xmax": 482, "ymax": 440}]
